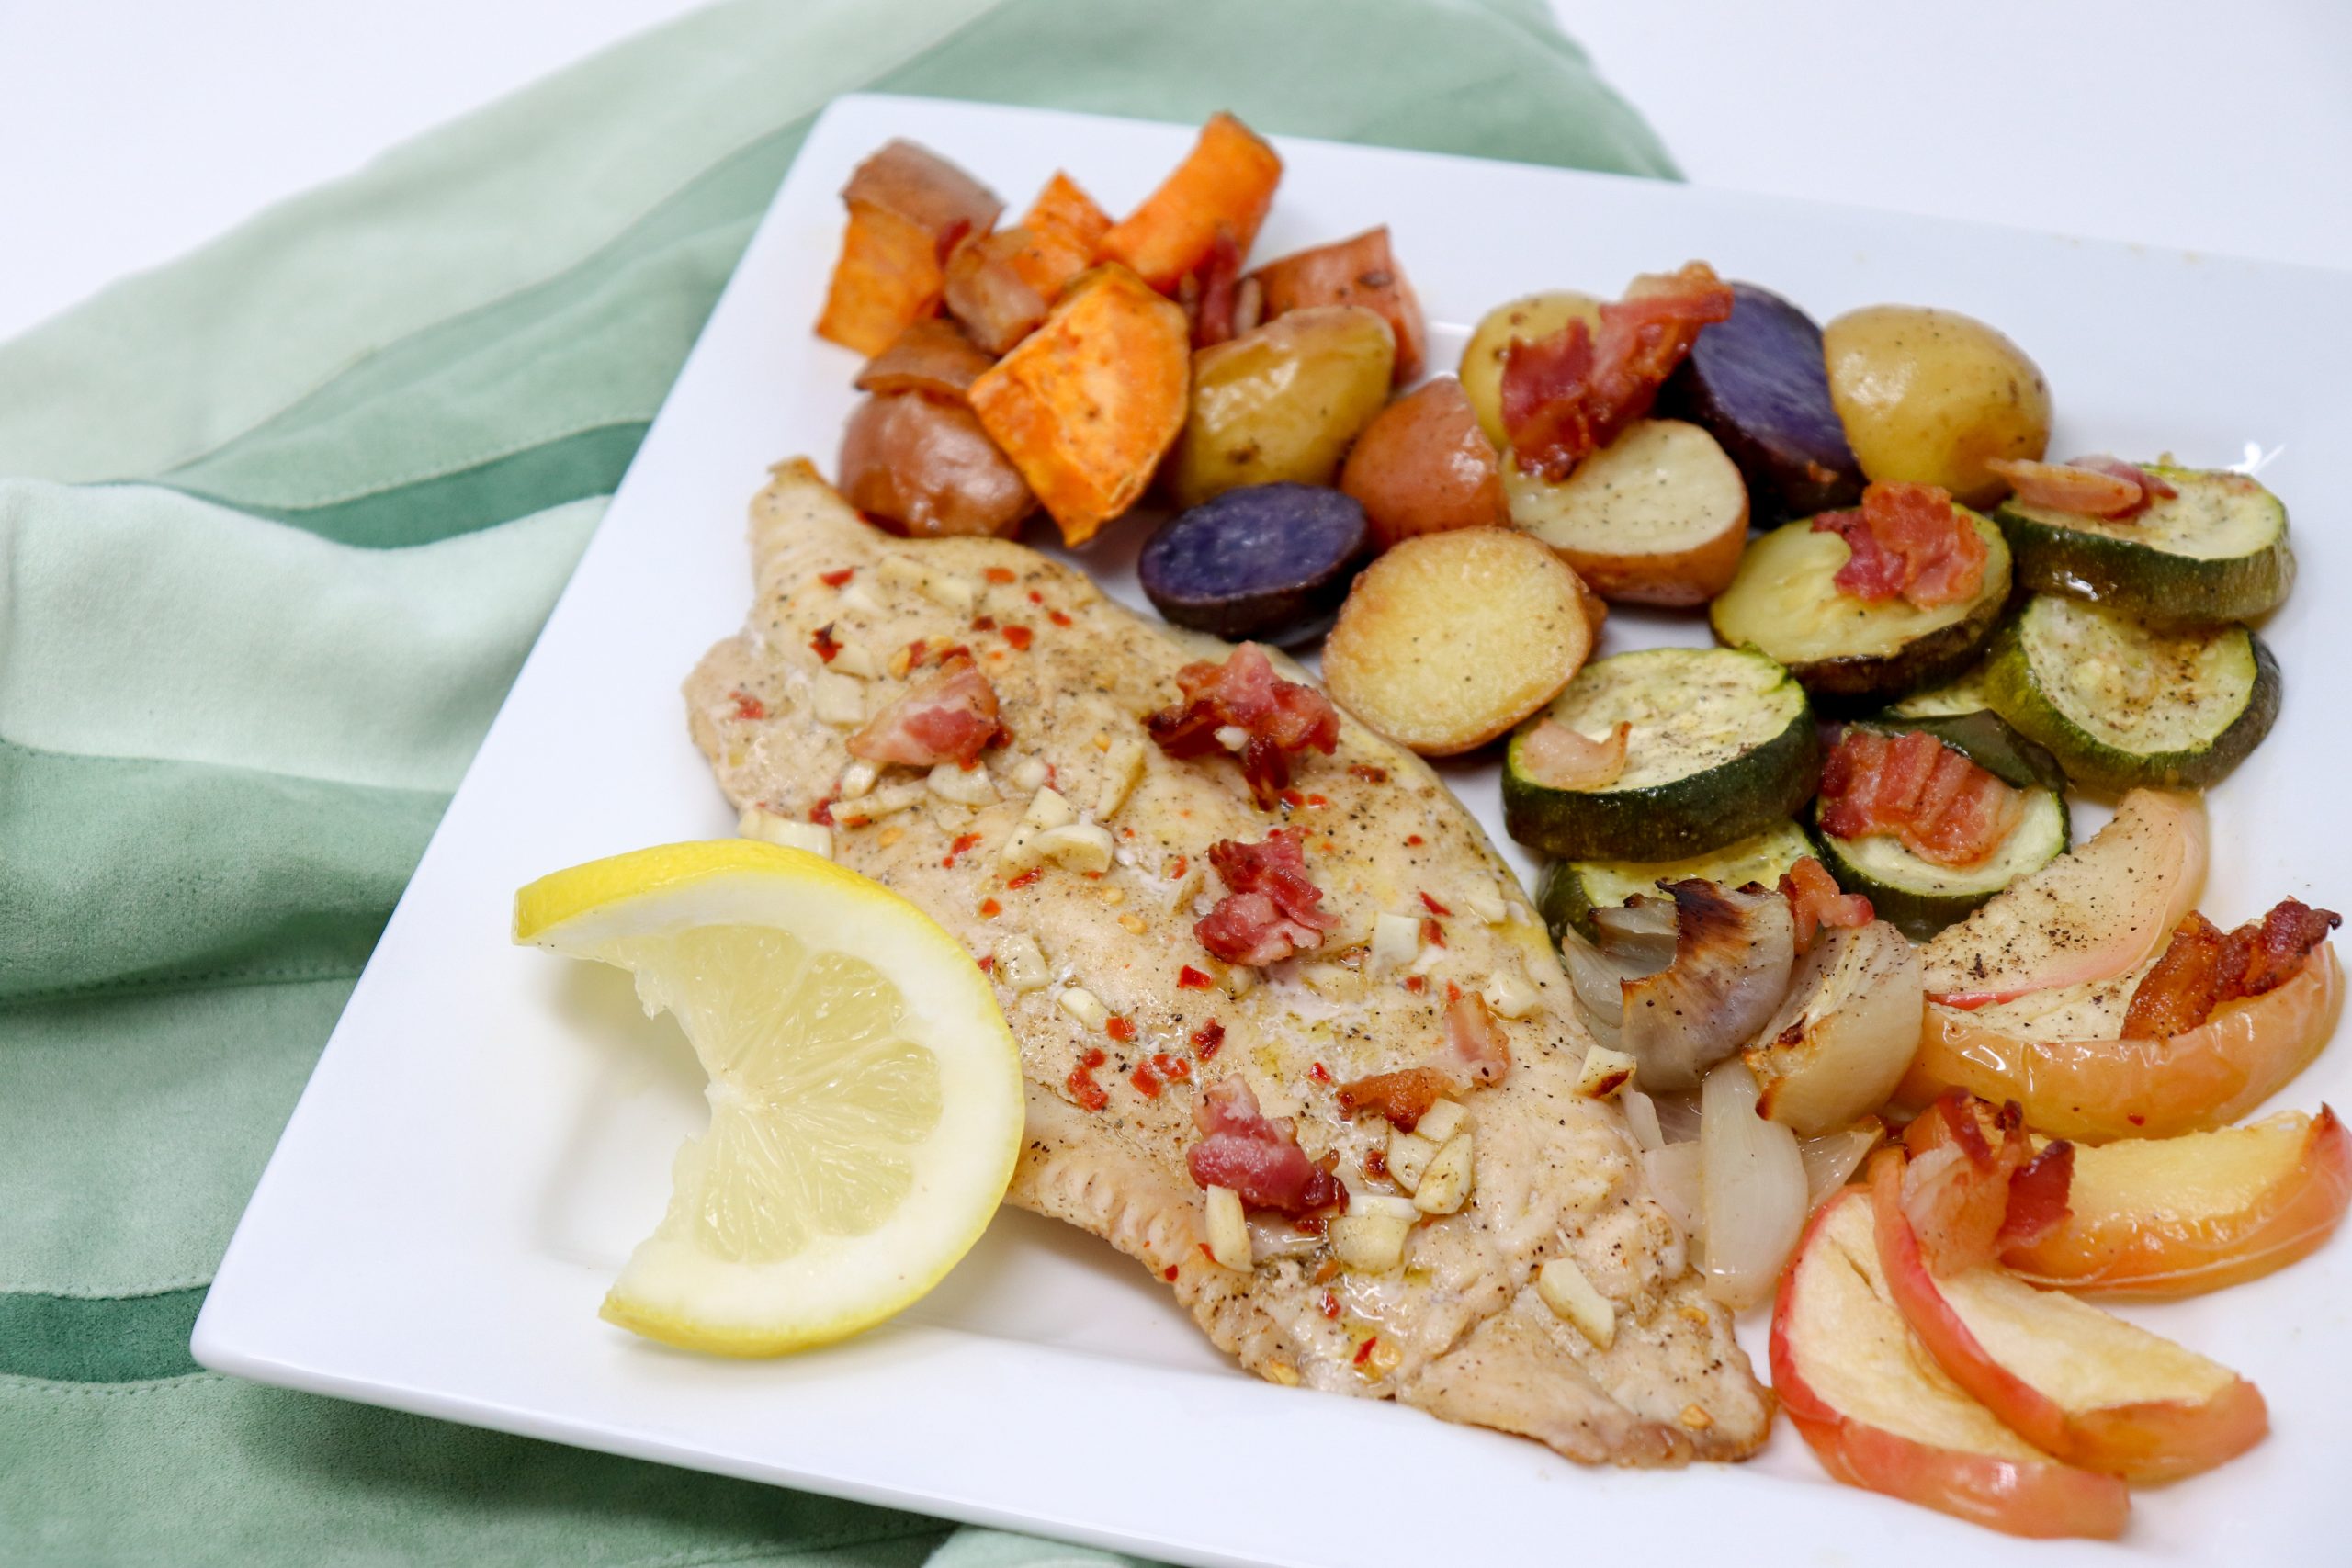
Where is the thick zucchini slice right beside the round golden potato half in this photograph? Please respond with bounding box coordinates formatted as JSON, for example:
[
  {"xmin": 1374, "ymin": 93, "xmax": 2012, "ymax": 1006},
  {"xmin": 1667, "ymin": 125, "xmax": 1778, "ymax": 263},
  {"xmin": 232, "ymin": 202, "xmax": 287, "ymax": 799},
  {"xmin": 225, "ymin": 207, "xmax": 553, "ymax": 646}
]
[{"xmin": 1503, "ymin": 649, "xmax": 1820, "ymax": 861}]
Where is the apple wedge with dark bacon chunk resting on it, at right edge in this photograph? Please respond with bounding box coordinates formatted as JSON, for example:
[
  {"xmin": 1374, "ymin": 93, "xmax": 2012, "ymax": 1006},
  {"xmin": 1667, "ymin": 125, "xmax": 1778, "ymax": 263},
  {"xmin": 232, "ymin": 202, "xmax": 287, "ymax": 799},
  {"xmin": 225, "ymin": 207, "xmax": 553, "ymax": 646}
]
[{"xmin": 1900, "ymin": 944, "xmax": 2343, "ymax": 1143}]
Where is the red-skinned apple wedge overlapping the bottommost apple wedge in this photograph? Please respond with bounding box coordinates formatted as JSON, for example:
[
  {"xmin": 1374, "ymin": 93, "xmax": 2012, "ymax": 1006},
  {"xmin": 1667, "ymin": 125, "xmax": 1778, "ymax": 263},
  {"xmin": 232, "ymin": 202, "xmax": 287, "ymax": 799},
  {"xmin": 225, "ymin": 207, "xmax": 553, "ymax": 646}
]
[{"xmin": 1870, "ymin": 1149, "xmax": 2269, "ymax": 1481}]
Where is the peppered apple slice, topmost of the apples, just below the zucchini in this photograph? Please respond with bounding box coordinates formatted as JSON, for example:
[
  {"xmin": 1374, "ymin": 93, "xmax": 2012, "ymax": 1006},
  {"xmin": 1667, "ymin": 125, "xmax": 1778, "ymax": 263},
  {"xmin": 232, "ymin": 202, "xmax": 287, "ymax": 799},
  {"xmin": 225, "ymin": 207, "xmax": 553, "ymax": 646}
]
[{"xmin": 1924, "ymin": 790, "xmax": 2206, "ymax": 1009}]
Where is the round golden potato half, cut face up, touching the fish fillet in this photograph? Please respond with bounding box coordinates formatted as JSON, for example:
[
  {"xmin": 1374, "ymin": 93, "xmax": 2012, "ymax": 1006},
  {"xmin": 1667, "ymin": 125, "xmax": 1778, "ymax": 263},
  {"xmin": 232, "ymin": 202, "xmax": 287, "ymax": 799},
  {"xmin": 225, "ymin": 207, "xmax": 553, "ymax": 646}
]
[{"xmin": 1322, "ymin": 529, "xmax": 1592, "ymax": 757}]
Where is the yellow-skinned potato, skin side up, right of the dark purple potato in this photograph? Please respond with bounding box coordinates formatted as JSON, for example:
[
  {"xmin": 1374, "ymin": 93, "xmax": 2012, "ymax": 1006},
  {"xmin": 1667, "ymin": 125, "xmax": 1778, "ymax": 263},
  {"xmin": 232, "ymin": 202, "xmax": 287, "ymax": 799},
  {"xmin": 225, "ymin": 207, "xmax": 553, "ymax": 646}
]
[{"xmin": 1823, "ymin": 306, "xmax": 2051, "ymax": 508}]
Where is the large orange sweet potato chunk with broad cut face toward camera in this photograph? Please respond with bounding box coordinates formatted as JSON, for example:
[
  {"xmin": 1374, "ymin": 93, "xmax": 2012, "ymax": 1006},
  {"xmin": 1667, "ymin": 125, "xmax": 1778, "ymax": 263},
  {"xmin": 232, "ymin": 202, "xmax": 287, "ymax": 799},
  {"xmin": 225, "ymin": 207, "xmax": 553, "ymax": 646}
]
[{"xmin": 967, "ymin": 265, "xmax": 1193, "ymax": 546}]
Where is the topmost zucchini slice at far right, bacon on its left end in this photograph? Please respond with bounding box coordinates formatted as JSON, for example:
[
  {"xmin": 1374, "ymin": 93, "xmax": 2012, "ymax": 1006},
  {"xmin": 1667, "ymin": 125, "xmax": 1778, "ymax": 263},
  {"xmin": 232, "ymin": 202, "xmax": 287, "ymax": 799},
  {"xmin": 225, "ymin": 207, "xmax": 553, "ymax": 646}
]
[{"xmin": 1995, "ymin": 466, "xmax": 2296, "ymax": 626}]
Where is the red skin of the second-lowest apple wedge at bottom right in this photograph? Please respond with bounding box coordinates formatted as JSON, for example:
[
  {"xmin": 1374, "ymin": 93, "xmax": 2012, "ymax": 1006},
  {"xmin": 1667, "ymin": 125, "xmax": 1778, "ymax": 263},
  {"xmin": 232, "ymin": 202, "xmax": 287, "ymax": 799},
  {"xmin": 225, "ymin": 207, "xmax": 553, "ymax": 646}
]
[{"xmin": 1870, "ymin": 1149, "xmax": 2269, "ymax": 1481}]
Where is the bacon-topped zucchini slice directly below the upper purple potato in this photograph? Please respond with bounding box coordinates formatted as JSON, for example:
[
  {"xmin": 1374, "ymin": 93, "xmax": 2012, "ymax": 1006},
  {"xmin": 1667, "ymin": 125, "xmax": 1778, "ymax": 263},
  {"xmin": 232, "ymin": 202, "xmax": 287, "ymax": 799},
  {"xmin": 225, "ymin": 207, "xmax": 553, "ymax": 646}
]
[{"xmin": 1708, "ymin": 508, "xmax": 2008, "ymax": 698}]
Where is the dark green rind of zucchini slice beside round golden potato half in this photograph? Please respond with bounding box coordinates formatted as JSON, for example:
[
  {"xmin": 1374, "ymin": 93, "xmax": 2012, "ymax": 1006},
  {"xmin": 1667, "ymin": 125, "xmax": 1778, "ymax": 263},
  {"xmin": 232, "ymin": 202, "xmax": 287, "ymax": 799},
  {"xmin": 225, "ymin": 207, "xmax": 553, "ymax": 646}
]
[{"xmin": 1503, "ymin": 703, "xmax": 1820, "ymax": 861}]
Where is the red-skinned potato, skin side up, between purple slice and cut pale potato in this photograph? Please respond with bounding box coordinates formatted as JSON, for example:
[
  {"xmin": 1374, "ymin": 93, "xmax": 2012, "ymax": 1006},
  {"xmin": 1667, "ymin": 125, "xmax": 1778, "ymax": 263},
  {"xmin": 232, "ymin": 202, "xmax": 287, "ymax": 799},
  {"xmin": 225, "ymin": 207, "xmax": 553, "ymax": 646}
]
[{"xmin": 1339, "ymin": 376, "xmax": 1508, "ymax": 550}]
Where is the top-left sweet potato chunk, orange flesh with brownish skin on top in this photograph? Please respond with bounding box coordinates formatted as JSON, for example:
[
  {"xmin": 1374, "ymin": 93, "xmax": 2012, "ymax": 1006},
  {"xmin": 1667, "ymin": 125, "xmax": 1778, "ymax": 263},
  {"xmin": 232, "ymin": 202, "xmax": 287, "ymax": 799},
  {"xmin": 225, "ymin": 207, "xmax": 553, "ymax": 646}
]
[{"xmin": 816, "ymin": 141, "xmax": 1004, "ymax": 357}]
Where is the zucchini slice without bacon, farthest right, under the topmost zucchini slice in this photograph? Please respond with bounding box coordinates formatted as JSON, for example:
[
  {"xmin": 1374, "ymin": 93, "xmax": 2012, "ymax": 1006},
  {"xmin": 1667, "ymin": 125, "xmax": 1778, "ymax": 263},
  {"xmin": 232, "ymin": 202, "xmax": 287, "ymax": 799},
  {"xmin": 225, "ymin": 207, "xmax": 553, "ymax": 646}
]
[{"xmin": 1985, "ymin": 594, "xmax": 2279, "ymax": 792}]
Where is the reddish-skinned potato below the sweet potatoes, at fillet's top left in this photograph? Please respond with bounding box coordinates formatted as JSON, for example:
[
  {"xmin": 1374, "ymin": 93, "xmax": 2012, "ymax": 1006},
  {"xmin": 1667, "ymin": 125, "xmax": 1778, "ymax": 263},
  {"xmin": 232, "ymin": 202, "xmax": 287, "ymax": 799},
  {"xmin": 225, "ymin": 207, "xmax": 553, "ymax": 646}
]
[{"xmin": 840, "ymin": 392, "xmax": 1037, "ymax": 538}]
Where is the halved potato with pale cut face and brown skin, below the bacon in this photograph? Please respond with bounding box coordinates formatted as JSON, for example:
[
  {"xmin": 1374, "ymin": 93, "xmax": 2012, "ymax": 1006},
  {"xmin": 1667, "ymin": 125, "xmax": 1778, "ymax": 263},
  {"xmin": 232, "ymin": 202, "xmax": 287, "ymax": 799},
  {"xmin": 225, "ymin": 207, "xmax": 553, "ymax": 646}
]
[{"xmin": 1503, "ymin": 419, "xmax": 1747, "ymax": 604}]
